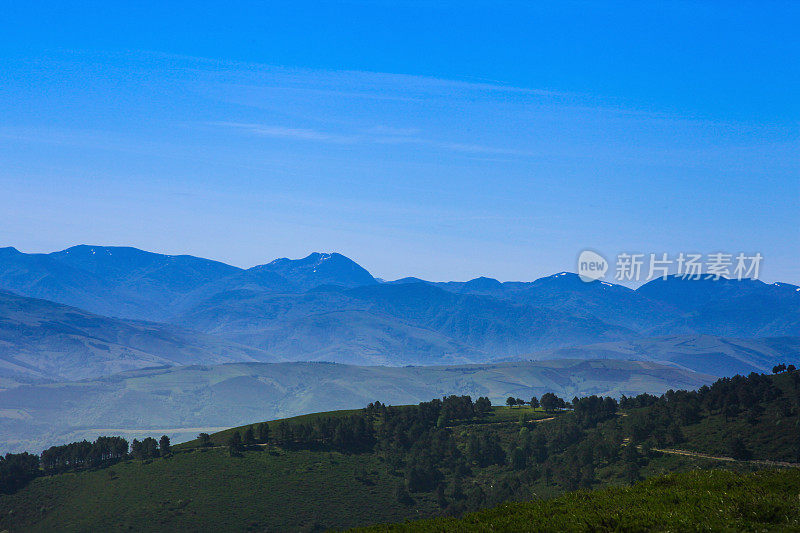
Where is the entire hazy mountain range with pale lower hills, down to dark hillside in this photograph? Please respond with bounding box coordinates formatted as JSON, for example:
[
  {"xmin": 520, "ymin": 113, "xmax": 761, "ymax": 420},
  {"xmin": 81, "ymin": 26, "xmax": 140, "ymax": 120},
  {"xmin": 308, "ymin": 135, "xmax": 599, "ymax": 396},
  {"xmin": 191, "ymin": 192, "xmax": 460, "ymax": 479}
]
[{"xmin": 0, "ymin": 246, "xmax": 800, "ymax": 450}]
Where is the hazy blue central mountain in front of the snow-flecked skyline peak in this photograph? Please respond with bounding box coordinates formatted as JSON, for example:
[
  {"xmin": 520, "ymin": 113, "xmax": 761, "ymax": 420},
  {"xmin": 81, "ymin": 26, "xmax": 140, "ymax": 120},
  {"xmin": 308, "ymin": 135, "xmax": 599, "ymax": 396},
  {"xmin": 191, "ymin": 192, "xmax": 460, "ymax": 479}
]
[{"xmin": 175, "ymin": 283, "xmax": 633, "ymax": 364}]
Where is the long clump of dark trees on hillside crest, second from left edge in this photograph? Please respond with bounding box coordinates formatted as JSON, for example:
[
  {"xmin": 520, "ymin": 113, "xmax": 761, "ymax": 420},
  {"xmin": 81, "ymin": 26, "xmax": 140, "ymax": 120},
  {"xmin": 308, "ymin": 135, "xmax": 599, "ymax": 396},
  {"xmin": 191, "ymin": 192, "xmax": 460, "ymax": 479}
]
[{"xmin": 41, "ymin": 437, "xmax": 130, "ymax": 474}]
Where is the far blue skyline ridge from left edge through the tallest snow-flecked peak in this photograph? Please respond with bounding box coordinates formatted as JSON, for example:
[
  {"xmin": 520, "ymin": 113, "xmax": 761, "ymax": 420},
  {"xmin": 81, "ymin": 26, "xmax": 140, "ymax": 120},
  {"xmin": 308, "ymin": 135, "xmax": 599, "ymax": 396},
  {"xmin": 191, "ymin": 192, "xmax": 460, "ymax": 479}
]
[{"xmin": 0, "ymin": 245, "xmax": 377, "ymax": 321}]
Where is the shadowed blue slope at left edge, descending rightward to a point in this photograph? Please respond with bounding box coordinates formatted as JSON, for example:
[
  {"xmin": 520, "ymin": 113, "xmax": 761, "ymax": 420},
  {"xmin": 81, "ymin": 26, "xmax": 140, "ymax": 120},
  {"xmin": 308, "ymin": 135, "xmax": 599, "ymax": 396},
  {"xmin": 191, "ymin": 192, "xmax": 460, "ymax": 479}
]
[{"xmin": 0, "ymin": 290, "xmax": 277, "ymax": 384}]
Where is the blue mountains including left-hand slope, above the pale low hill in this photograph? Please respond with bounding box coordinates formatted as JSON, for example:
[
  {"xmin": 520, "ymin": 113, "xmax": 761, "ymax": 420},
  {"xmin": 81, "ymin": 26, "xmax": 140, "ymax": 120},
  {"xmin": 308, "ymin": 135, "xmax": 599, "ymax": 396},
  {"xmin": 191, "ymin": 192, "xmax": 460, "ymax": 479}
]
[{"xmin": 0, "ymin": 245, "xmax": 800, "ymax": 380}]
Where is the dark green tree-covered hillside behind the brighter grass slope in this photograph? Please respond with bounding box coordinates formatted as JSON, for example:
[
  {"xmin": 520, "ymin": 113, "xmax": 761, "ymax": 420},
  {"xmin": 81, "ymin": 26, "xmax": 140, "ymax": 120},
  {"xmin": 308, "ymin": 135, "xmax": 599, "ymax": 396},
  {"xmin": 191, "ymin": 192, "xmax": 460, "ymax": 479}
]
[{"xmin": 0, "ymin": 369, "xmax": 800, "ymax": 531}]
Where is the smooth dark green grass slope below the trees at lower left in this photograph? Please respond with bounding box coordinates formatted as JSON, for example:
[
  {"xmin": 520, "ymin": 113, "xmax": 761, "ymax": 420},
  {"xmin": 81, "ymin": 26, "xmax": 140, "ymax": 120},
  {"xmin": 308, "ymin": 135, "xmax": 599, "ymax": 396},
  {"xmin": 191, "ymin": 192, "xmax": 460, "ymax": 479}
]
[{"xmin": 0, "ymin": 449, "xmax": 438, "ymax": 531}]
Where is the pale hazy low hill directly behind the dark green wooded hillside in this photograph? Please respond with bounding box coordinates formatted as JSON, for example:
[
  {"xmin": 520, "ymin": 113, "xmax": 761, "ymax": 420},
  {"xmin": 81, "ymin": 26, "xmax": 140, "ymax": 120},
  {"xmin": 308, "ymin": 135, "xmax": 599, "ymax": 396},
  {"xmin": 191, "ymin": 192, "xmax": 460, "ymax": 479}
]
[{"xmin": 0, "ymin": 360, "xmax": 713, "ymax": 452}]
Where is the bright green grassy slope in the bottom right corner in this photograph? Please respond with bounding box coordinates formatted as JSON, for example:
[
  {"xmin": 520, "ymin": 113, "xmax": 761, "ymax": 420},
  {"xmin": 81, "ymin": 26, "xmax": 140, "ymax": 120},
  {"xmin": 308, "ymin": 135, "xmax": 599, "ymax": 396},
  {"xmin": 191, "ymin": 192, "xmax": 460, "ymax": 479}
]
[{"xmin": 359, "ymin": 469, "xmax": 800, "ymax": 533}]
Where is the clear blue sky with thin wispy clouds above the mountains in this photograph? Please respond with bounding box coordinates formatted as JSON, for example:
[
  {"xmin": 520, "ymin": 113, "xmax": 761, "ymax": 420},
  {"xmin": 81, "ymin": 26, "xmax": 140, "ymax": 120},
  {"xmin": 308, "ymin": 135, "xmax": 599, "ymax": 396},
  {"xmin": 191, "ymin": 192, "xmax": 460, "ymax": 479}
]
[{"xmin": 0, "ymin": 1, "xmax": 800, "ymax": 283}]
